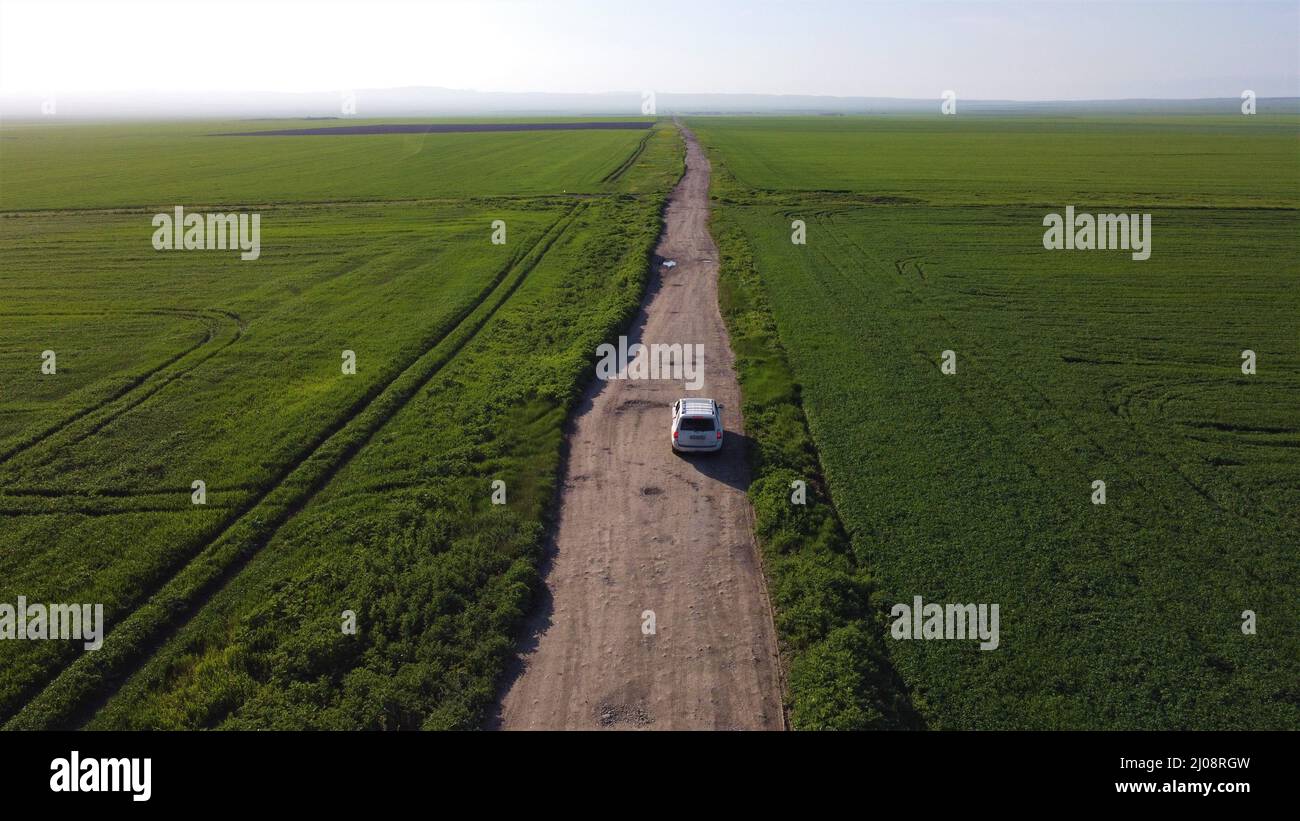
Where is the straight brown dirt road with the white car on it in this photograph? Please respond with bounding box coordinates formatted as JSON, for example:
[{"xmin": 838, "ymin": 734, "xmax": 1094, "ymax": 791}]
[{"xmin": 491, "ymin": 123, "xmax": 783, "ymax": 729}]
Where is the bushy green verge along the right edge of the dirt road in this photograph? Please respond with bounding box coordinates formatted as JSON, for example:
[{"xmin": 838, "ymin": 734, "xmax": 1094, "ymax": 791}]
[{"xmin": 712, "ymin": 200, "xmax": 919, "ymax": 730}]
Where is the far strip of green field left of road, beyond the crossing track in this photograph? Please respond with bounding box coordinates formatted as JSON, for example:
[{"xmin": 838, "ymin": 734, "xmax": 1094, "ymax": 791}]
[{"xmin": 0, "ymin": 118, "xmax": 662, "ymax": 212}]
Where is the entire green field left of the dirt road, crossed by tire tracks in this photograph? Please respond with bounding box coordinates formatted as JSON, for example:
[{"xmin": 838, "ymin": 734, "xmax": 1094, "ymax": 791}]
[{"xmin": 0, "ymin": 123, "xmax": 681, "ymax": 729}]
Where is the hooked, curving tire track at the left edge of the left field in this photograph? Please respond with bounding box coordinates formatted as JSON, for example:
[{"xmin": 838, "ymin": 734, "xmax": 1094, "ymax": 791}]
[{"xmin": 0, "ymin": 308, "xmax": 246, "ymax": 465}]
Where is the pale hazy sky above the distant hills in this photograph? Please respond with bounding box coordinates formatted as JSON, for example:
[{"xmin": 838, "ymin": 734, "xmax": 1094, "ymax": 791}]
[{"xmin": 0, "ymin": 0, "xmax": 1300, "ymax": 100}]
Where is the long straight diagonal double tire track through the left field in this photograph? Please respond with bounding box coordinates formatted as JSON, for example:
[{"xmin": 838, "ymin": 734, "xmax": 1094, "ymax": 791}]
[{"xmin": 0, "ymin": 203, "xmax": 586, "ymax": 730}]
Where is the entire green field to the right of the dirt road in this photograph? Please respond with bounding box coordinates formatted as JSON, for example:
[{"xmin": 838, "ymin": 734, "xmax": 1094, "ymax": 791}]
[{"xmin": 689, "ymin": 117, "xmax": 1300, "ymax": 729}]
